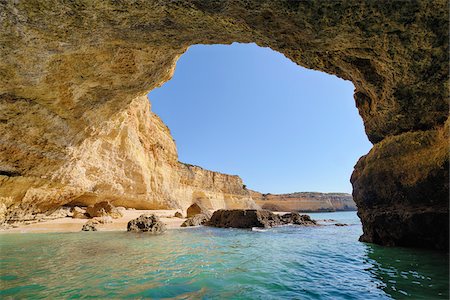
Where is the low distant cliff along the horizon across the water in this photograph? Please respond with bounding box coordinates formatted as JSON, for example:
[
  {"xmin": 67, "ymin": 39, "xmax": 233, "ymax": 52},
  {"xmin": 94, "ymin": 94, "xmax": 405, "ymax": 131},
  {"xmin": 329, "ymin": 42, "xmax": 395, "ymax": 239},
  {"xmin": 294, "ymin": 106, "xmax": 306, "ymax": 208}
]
[{"xmin": 251, "ymin": 191, "xmax": 356, "ymax": 212}]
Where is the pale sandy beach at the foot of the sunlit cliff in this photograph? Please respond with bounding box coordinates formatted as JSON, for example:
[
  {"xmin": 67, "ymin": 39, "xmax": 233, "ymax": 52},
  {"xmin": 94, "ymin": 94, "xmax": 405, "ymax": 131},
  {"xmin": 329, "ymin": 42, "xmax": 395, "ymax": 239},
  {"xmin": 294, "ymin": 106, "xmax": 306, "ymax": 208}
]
[{"xmin": 0, "ymin": 210, "xmax": 186, "ymax": 234}]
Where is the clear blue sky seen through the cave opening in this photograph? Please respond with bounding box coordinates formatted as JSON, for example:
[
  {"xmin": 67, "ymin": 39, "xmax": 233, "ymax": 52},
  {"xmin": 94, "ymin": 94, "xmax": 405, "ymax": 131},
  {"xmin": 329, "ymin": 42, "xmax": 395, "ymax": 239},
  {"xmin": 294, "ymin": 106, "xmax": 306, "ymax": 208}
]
[{"xmin": 149, "ymin": 43, "xmax": 371, "ymax": 193}]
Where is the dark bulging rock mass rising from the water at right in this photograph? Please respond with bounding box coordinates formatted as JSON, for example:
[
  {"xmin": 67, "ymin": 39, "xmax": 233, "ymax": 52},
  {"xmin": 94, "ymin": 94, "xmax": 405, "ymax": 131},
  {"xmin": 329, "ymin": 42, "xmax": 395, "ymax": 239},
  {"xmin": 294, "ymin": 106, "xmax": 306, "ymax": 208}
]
[{"xmin": 351, "ymin": 128, "xmax": 449, "ymax": 250}]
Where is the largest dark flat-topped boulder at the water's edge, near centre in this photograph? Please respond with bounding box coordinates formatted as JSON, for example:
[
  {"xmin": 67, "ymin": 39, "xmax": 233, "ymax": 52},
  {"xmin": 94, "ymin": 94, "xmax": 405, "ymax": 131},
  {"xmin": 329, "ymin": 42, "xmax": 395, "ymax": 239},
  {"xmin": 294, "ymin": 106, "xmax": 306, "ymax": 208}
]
[{"xmin": 207, "ymin": 209, "xmax": 285, "ymax": 228}]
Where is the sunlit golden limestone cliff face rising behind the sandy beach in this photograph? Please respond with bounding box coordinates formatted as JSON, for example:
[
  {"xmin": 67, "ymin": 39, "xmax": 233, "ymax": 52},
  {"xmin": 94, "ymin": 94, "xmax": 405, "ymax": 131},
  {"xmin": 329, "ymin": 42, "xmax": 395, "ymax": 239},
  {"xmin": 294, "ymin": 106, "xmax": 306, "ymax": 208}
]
[{"xmin": 0, "ymin": 96, "xmax": 257, "ymax": 221}]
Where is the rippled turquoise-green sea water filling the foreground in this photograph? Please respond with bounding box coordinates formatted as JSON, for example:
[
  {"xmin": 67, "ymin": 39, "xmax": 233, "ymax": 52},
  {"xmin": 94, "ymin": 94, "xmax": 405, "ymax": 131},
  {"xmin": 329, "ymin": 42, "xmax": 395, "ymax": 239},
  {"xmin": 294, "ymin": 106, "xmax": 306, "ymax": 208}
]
[{"xmin": 0, "ymin": 212, "xmax": 449, "ymax": 299}]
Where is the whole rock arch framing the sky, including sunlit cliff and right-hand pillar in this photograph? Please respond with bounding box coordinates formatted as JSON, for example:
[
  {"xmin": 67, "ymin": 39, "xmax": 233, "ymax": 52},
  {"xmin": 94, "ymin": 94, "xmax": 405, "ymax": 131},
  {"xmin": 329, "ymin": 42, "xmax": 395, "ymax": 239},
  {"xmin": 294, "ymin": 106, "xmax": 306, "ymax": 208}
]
[{"xmin": 0, "ymin": 0, "xmax": 448, "ymax": 248}]
